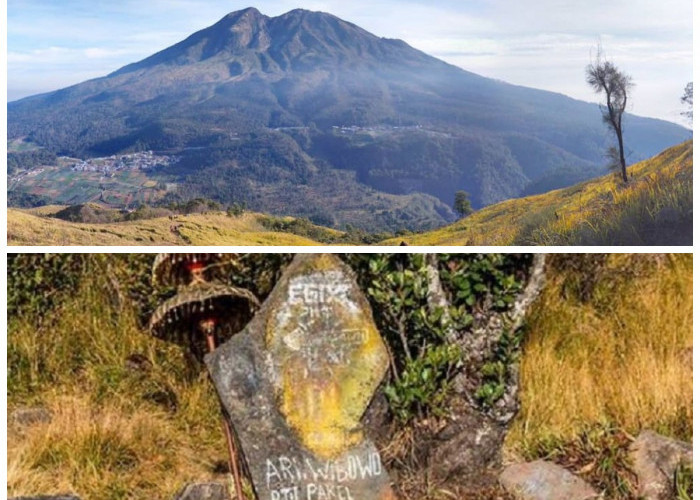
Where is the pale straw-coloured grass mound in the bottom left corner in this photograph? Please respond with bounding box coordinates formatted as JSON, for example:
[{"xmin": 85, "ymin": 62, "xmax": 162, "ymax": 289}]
[{"xmin": 7, "ymin": 394, "xmax": 211, "ymax": 499}]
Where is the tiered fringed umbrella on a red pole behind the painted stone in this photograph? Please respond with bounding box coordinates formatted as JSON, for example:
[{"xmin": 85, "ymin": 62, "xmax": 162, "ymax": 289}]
[{"xmin": 149, "ymin": 254, "xmax": 260, "ymax": 500}]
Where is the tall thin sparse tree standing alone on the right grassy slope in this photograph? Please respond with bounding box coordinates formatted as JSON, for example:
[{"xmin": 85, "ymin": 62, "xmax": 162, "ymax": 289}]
[{"xmin": 586, "ymin": 46, "xmax": 633, "ymax": 182}]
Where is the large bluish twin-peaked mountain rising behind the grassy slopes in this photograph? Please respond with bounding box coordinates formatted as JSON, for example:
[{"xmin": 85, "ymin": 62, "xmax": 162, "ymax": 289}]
[{"xmin": 8, "ymin": 8, "xmax": 691, "ymax": 230}]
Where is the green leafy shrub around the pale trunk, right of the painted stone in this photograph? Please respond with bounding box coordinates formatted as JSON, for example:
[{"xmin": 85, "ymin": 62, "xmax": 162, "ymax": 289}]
[{"xmin": 356, "ymin": 254, "xmax": 526, "ymax": 423}]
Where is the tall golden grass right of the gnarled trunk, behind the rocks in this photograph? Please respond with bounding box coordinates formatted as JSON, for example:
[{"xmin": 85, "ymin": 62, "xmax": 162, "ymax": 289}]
[{"xmin": 508, "ymin": 255, "xmax": 693, "ymax": 456}]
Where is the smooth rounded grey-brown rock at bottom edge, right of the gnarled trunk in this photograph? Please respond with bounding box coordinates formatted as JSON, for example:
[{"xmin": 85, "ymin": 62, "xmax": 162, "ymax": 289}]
[{"xmin": 500, "ymin": 460, "xmax": 599, "ymax": 500}]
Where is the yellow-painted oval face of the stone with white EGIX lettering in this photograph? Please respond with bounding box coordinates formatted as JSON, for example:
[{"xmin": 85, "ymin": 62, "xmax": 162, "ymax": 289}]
[{"xmin": 265, "ymin": 255, "xmax": 389, "ymax": 458}]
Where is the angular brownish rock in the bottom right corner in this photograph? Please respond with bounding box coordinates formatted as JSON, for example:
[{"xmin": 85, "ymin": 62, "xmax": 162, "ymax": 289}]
[{"xmin": 630, "ymin": 431, "xmax": 693, "ymax": 500}]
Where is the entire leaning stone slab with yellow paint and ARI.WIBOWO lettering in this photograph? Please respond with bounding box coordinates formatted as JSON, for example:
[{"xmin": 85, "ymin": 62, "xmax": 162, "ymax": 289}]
[{"xmin": 205, "ymin": 254, "xmax": 395, "ymax": 500}]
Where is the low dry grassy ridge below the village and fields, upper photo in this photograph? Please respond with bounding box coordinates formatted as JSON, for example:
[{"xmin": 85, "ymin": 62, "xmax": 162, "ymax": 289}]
[{"xmin": 7, "ymin": 206, "xmax": 334, "ymax": 246}]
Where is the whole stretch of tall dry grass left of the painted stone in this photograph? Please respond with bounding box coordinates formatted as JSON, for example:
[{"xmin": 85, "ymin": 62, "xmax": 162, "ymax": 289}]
[{"xmin": 8, "ymin": 266, "xmax": 227, "ymax": 500}]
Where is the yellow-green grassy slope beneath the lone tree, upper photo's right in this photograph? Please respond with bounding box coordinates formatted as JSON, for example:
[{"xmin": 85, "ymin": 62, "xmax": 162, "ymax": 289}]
[{"xmin": 384, "ymin": 141, "xmax": 693, "ymax": 245}]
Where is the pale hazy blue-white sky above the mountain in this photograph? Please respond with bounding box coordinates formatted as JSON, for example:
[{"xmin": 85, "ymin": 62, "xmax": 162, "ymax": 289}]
[{"xmin": 7, "ymin": 0, "xmax": 693, "ymax": 126}]
